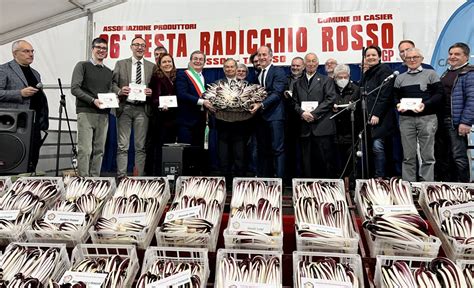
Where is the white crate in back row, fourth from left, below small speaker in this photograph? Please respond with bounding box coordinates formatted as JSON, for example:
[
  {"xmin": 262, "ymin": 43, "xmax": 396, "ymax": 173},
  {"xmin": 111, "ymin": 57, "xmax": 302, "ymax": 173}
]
[{"xmin": 155, "ymin": 176, "xmax": 225, "ymax": 252}]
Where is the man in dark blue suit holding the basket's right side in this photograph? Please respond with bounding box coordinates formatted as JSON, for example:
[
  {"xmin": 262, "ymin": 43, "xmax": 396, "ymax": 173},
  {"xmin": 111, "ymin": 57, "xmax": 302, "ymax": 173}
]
[{"xmin": 251, "ymin": 46, "xmax": 286, "ymax": 178}]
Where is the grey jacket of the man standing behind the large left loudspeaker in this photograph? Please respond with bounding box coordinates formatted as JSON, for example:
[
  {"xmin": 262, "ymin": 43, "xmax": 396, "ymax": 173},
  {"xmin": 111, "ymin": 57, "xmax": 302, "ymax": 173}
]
[{"xmin": 0, "ymin": 60, "xmax": 49, "ymax": 130}]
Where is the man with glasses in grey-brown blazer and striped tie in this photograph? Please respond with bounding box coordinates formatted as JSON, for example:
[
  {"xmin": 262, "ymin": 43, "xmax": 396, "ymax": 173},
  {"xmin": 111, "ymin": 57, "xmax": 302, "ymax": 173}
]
[{"xmin": 112, "ymin": 37, "xmax": 154, "ymax": 178}]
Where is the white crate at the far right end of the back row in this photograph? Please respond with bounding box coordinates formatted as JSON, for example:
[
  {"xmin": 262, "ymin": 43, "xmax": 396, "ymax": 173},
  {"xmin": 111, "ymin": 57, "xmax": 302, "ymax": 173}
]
[{"xmin": 418, "ymin": 182, "xmax": 474, "ymax": 261}]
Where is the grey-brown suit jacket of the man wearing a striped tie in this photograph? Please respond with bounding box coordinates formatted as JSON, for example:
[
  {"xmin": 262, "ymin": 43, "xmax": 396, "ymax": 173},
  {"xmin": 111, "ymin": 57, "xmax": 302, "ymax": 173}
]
[{"xmin": 112, "ymin": 57, "xmax": 155, "ymax": 117}]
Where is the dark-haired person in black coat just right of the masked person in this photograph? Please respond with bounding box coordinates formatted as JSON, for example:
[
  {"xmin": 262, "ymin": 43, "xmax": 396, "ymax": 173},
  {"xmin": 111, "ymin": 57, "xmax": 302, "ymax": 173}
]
[{"xmin": 360, "ymin": 46, "xmax": 395, "ymax": 177}]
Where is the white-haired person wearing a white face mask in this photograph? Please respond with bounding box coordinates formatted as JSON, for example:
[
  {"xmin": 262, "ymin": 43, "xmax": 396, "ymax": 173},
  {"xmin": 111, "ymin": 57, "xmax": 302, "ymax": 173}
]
[{"xmin": 333, "ymin": 64, "xmax": 359, "ymax": 176}]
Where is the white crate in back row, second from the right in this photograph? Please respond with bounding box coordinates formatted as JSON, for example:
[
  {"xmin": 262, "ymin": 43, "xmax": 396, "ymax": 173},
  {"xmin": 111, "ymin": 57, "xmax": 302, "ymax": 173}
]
[{"xmin": 354, "ymin": 179, "xmax": 441, "ymax": 257}]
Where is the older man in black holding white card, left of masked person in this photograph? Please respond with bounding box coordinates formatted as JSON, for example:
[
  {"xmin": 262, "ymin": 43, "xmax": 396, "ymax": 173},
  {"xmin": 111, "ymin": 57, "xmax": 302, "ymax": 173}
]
[{"xmin": 293, "ymin": 53, "xmax": 337, "ymax": 178}]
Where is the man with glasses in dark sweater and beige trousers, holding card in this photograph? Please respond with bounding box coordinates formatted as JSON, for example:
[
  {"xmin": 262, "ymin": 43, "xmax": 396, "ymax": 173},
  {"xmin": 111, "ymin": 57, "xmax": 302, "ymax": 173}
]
[{"xmin": 71, "ymin": 38, "xmax": 112, "ymax": 177}]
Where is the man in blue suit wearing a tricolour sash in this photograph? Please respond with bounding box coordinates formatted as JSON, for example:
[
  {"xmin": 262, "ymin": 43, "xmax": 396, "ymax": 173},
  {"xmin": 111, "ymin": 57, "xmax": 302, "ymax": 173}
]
[{"xmin": 176, "ymin": 51, "xmax": 215, "ymax": 148}]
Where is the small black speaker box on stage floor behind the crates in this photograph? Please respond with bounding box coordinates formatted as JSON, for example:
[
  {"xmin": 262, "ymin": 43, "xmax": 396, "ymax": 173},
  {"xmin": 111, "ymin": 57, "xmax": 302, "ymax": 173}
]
[{"xmin": 161, "ymin": 143, "xmax": 202, "ymax": 176}]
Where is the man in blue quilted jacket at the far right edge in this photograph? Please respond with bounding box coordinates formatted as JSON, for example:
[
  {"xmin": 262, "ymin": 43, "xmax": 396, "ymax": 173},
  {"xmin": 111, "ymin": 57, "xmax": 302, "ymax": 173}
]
[{"xmin": 436, "ymin": 42, "xmax": 474, "ymax": 183}]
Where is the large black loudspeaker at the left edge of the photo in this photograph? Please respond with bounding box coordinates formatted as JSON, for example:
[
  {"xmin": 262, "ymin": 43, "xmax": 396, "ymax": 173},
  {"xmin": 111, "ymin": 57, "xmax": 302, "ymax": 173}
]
[{"xmin": 0, "ymin": 108, "xmax": 35, "ymax": 174}]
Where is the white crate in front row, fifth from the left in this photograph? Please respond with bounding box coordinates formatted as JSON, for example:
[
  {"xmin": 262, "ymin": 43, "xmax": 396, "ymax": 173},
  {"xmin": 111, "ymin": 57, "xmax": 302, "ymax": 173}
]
[{"xmin": 293, "ymin": 251, "xmax": 364, "ymax": 288}]
